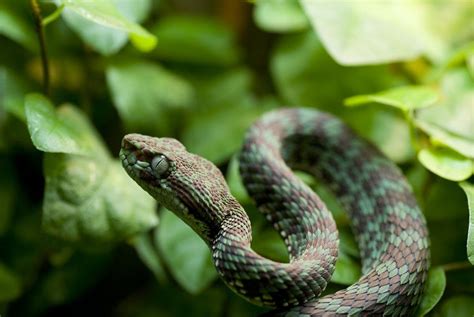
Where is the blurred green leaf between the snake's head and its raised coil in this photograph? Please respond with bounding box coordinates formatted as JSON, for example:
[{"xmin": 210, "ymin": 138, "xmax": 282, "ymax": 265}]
[{"xmin": 182, "ymin": 68, "xmax": 262, "ymax": 163}]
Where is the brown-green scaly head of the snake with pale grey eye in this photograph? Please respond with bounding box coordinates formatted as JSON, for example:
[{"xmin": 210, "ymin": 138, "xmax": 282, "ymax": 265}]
[{"xmin": 120, "ymin": 134, "xmax": 233, "ymax": 243}]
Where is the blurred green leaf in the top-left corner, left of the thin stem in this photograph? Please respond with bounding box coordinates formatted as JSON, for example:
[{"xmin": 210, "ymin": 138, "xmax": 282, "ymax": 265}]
[{"xmin": 0, "ymin": 1, "xmax": 37, "ymax": 51}]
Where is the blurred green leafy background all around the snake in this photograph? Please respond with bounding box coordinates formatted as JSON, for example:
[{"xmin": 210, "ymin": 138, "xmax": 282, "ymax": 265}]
[{"xmin": 0, "ymin": 0, "xmax": 474, "ymax": 317}]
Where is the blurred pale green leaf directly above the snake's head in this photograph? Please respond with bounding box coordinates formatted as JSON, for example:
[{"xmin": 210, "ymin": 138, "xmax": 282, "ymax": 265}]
[{"xmin": 106, "ymin": 60, "xmax": 194, "ymax": 134}]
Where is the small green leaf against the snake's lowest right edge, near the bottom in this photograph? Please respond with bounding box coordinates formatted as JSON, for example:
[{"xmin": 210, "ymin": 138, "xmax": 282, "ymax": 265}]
[{"xmin": 416, "ymin": 267, "xmax": 446, "ymax": 317}]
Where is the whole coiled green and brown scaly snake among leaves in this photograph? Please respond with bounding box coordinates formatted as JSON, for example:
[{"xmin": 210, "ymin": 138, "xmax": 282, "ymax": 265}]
[{"xmin": 119, "ymin": 107, "xmax": 430, "ymax": 317}]
